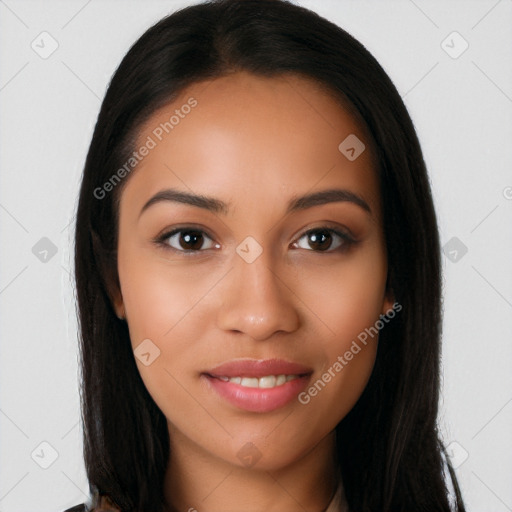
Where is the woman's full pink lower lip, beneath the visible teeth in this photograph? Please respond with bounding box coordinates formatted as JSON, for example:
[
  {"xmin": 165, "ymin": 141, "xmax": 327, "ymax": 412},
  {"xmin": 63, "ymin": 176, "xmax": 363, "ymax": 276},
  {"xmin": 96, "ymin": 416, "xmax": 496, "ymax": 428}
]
[{"xmin": 201, "ymin": 374, "xmax": 311, "ymax": 412}]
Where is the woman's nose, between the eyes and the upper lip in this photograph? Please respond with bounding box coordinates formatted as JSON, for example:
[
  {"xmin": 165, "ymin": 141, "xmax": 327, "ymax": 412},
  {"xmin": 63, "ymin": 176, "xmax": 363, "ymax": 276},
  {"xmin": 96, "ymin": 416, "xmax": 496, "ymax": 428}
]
[{"xmin": 217, "ymin": 252, "xmax": 300, "ymax": 341}]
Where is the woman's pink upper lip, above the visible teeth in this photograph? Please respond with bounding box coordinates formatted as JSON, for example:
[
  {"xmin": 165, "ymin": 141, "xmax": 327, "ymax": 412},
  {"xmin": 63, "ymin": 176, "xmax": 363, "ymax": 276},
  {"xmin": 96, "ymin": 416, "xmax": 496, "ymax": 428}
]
[{"xmin": 204, "ymin": 359, "xmax": 313, "ymax": 377}]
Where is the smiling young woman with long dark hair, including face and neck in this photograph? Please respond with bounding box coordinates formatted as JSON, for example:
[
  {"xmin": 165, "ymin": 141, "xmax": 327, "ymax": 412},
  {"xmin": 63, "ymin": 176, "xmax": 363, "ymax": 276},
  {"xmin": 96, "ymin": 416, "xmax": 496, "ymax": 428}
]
[{"xmin": 67, "ymin": 0, "xmax": 464, "ymax": 512}]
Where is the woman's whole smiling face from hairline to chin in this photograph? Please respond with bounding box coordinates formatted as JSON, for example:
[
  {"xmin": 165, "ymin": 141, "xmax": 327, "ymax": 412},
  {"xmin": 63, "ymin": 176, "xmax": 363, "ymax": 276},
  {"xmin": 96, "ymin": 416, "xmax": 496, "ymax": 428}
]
[{"xmin": 115, "ymin": 73, "xmax": 392, "ymax": 469}]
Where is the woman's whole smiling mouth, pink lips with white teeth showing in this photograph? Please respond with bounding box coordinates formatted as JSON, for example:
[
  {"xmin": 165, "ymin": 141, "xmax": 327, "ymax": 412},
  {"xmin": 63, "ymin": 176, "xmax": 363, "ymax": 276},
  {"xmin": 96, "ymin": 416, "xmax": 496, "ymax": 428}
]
[{"xmin": 201, "ymin": 359, "xmax": 313, "ymax": 413}]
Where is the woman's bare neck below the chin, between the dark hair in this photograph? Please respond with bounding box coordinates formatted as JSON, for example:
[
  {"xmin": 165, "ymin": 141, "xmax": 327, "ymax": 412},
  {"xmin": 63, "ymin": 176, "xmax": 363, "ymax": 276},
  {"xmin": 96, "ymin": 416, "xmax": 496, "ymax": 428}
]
[{"xmin": 164, "ymin": 426, "xmax": 339, "ymax": 512}]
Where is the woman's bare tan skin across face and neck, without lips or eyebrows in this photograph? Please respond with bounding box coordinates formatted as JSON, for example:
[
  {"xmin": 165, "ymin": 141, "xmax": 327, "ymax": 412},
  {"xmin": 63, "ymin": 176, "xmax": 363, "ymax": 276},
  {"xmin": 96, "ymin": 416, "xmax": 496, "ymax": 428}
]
[{"xmin": 114, "ymin": 72, "xmax": 393, "ymax": 512}]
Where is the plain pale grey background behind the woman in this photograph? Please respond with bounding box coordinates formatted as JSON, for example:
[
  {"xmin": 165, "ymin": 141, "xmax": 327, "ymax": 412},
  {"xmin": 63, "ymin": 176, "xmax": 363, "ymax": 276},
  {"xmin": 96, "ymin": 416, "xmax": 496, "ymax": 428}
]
[{"xmin": 0, "ymin": 0, "xmax": 512, "ymax": 512}]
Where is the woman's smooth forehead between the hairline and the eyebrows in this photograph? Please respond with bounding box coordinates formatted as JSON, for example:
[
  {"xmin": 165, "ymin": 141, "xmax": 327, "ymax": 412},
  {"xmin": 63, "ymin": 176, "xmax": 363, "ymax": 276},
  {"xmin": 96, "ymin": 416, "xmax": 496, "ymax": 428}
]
[{"xmin": 121, "ymin": 72, "xmax": 380, "ymax": 222}]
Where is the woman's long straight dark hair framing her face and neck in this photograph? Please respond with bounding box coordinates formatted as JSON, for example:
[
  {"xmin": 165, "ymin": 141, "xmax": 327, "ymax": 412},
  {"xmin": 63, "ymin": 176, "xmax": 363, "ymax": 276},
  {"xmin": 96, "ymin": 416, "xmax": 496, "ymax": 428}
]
[{"xmin": 75, "ymin": 0, "xmax": 465, "ymax": 512}]
